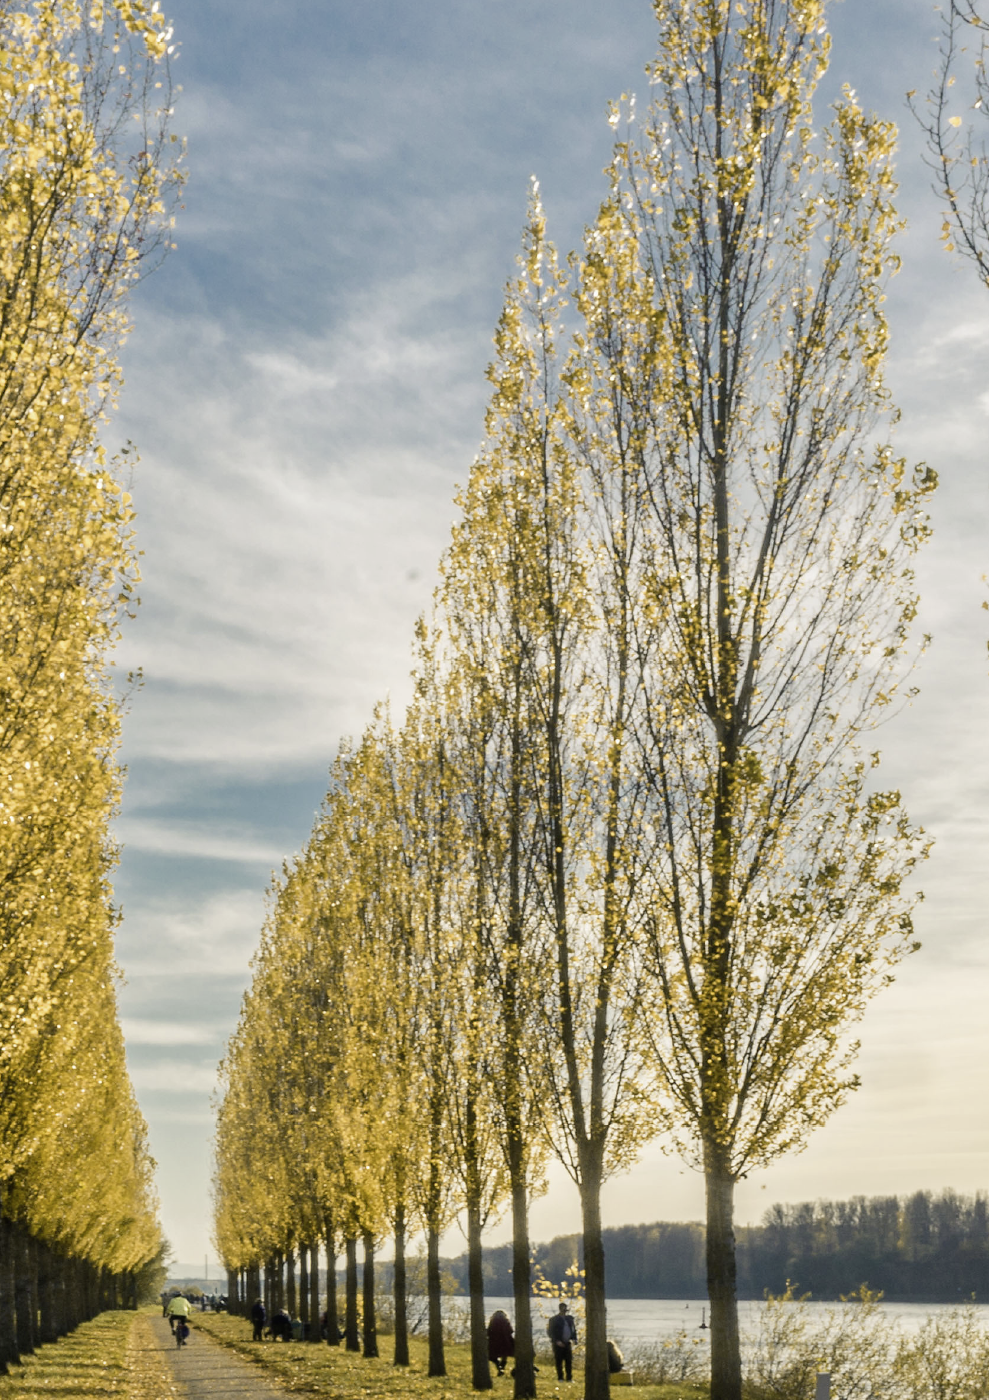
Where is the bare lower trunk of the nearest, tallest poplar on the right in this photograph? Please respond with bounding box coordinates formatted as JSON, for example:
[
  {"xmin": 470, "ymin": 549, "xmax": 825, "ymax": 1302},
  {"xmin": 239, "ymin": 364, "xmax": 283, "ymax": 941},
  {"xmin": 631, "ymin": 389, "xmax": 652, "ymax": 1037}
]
[{"xmin": 705, "ymin": 1144, "xmax": 741, "ymax": 1400}]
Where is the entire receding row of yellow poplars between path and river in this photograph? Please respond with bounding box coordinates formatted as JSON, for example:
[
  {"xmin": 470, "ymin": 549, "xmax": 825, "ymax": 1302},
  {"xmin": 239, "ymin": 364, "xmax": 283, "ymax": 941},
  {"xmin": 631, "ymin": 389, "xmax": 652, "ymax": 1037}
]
[{"xmin": 216, "ymin": 0, "xmax": 934, "ymax": 1400}]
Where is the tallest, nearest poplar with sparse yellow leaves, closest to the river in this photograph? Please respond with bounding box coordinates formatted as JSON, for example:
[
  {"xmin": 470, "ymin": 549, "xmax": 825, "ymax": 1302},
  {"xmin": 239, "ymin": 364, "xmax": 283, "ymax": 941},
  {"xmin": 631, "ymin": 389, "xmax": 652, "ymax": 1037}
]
[{"xmin": 593, "ymin": 0, "xmax": 934, "ymax": 1400}]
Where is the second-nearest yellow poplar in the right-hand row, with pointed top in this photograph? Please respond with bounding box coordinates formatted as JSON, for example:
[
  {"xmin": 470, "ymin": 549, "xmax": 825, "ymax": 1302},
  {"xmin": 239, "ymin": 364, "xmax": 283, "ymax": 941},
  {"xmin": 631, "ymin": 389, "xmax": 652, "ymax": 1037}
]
[{"xmin": 448, "ymin": 200, "xmax": 651, "ymax": 1397}]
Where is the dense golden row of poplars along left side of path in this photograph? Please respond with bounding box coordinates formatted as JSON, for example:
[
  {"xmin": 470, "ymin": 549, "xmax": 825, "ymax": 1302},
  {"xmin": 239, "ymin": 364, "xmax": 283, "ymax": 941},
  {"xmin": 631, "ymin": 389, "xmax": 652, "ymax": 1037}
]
[{"xmin": 0, "ymin": 0, "xmax": 180, "ymax": 1371}]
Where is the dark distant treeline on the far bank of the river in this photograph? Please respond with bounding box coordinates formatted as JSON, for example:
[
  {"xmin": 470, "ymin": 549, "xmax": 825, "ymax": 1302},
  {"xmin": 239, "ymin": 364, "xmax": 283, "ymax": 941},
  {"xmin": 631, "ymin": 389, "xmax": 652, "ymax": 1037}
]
[{"xmin": 444, "ymin": 1191, "xmax": 989, "ymax": 1302}]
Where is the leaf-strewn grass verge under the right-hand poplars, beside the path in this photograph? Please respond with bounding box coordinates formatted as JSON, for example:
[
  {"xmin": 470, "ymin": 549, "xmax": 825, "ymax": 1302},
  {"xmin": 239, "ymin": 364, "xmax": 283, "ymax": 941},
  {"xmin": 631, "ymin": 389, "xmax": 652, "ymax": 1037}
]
[{"xmin": 193, "ymin": 1313, "xmax": 707, "ymax": 1400}]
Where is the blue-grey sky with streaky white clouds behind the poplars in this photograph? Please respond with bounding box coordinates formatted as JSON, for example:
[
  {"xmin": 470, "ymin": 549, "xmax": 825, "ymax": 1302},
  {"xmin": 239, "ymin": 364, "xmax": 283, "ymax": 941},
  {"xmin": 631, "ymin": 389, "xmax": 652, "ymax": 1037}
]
[{"xmin": 105, "ymin": 0, "xmax": 989, "ymax": 1274}]
